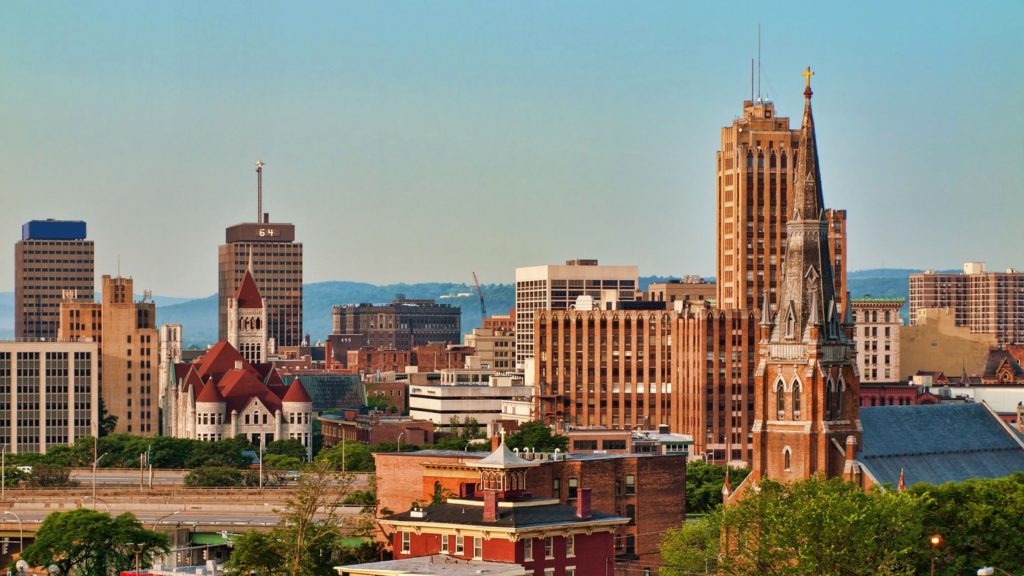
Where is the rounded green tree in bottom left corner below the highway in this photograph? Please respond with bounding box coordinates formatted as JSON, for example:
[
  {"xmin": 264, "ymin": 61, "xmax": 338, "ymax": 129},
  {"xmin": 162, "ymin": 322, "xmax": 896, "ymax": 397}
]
[{"xmin": 23, "ymin": 508, "xmax": 169, "ymax": 576}]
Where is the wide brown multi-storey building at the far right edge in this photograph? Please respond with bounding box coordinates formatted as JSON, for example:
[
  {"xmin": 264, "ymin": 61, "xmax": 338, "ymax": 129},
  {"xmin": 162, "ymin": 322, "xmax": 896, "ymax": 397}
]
[{"xmin": 910, "ymin": 262, "xmax": 1024, "ymax": 345}]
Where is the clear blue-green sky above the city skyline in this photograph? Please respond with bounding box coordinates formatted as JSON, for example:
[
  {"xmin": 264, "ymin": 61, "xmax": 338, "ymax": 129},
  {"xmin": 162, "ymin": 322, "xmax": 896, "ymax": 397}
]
[{"xmin": 0, "ymin": 0, "xmax": 1024, "ymax": 297}]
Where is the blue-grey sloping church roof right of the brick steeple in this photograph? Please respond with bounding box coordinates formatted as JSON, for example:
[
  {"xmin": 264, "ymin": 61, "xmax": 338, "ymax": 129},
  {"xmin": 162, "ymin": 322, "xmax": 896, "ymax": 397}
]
[{"xmin": 857, "ymin": 404, "xmax": 1024, "ymax": 486}]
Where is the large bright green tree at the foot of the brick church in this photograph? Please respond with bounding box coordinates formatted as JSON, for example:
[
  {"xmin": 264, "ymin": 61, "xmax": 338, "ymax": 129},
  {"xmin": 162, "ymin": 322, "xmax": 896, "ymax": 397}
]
[{"xmin": 662, "ymin": 478, "xmax": 925, "ymax": 576}]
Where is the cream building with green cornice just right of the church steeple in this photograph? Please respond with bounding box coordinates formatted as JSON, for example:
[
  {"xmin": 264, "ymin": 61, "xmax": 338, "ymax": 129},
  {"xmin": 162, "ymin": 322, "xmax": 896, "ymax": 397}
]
[{"xmin": 850, "ymin": 298, "xmax": 905, "ymax": 383}]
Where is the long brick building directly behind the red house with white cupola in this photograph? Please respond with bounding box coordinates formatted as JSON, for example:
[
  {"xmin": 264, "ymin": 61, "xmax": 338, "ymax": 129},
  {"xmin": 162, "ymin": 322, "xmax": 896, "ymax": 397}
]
[{"xmin": 374, "ymin": 438, "xmax": 686, "ymax": 574}]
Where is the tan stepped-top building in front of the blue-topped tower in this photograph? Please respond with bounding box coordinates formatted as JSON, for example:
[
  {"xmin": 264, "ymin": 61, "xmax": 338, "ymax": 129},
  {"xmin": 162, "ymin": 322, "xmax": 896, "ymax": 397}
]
[{"xmin": 58, "ymin": 275, "xmax": 160, "ymax": 436}]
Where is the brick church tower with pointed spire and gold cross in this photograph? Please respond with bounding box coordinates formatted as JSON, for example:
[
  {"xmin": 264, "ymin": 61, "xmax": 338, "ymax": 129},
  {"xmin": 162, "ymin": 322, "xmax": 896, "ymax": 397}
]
[{"xmin": 752, "ymin": 69, "xmax": 860, "ymax": 482}]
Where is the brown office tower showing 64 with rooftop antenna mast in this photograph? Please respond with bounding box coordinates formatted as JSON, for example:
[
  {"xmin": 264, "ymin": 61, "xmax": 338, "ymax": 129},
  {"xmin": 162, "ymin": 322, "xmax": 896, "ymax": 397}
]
[{"xmin": 217, "ymin": 162, "xmax": 303, "ymax": 347}]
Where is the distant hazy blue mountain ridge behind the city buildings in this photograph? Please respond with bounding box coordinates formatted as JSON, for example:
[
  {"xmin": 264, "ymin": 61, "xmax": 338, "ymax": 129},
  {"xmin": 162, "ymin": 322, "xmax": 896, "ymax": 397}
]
[{"xmin": 0, "ymin": 269, "xmax": 925, "ymax": 346}]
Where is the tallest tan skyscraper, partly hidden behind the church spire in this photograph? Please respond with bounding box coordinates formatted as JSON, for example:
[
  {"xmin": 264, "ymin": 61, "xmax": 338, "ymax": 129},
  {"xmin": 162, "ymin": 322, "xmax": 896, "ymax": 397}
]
[{"xmin": 716, "ymin": 100, "xmax": 846, "ymax": 310}]
